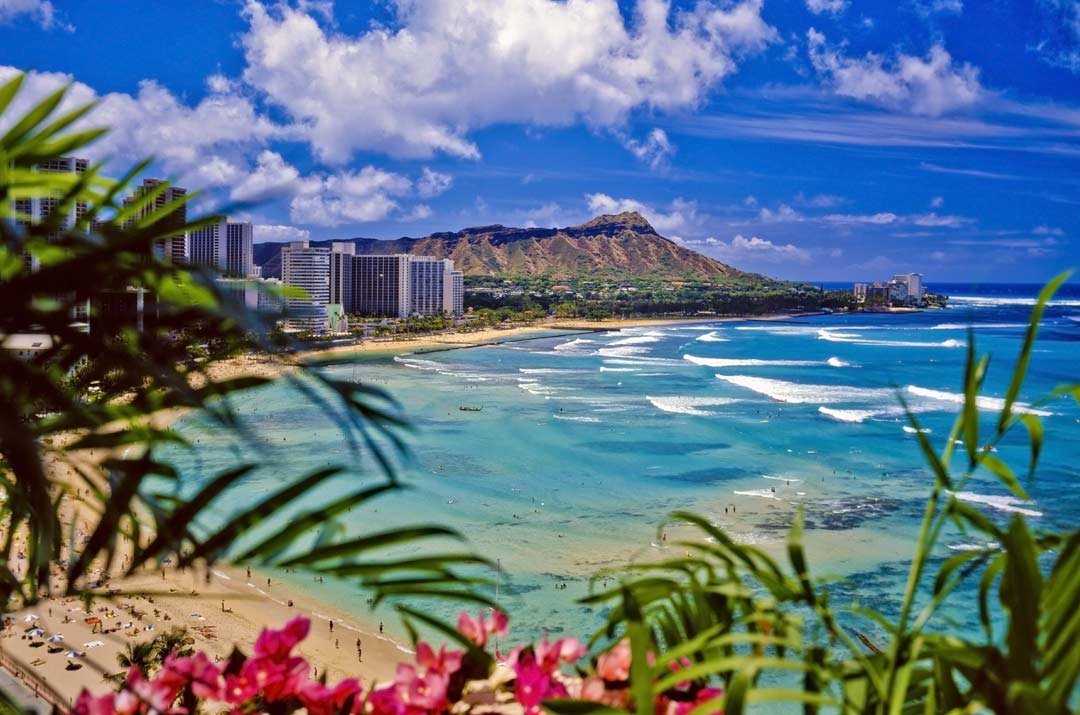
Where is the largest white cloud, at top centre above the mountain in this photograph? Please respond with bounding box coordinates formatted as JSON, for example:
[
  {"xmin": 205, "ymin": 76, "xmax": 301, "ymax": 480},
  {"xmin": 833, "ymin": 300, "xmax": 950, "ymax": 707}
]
[{"xmin": 241, "ymin": 0, "xmax": 777, "ymax": 162}]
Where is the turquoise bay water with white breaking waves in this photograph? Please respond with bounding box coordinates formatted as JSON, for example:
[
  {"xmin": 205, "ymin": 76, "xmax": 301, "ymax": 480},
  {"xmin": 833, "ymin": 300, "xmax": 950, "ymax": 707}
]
[{"xmin": 166, "ymin": 286, "xmax": 1080, "ymax": 656}]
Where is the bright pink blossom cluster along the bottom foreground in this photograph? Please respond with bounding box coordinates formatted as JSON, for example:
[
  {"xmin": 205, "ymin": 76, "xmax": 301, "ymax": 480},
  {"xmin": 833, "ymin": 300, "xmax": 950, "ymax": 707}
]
[{"xmin": 73, "ymin": 611, "xmax": 723, "ymax": 715}]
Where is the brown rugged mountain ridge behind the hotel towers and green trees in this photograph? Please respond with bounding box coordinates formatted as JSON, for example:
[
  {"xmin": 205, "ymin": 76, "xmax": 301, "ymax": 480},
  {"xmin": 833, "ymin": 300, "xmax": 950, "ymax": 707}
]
[{"xmin": 255, "ymin": 212, "xmax": 751, "ymax": 281}]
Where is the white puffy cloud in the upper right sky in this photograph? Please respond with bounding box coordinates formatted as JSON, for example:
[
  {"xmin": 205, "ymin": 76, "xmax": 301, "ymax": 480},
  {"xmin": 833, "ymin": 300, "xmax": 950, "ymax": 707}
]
[{"xmin": 807, "ymin": 28, "xmax": 985, "ymax": 117}]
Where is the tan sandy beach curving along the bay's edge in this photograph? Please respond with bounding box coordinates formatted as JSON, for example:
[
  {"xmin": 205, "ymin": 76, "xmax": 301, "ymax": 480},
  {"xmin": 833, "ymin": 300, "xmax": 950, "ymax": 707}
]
[{"xmin": 6, "ymin": 313, "xmax": 816, "ymax": 701}]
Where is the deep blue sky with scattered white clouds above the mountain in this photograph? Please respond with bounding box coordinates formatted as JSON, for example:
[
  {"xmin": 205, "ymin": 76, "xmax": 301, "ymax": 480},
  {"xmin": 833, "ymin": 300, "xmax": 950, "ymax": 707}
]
[{"xmin": 0, "ymin": 0, "xmax": 1080, "ymax": 282}]
